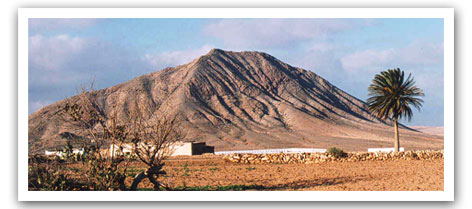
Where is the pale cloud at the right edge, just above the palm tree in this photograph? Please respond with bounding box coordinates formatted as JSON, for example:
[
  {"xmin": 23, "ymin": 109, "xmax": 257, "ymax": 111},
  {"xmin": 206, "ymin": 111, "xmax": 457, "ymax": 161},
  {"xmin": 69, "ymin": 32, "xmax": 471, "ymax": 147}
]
[{"xmin": 340, "ymin": 43, "xmax": 444, "ymax": 72}]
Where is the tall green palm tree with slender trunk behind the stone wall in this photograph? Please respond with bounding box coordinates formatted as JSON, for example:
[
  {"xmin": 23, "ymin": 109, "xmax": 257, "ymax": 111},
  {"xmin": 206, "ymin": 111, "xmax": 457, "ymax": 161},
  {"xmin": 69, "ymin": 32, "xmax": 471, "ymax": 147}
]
[{"xmin": 367, "ymin": 68, "xmax": 424, "ymax": 152}]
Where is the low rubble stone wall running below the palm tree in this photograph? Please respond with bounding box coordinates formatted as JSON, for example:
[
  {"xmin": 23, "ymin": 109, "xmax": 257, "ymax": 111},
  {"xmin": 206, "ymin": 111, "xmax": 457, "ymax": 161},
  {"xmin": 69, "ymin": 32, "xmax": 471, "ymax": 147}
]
[{"xmin": 223, "ymin": 150, "xmax": 444, "ymax": 164}]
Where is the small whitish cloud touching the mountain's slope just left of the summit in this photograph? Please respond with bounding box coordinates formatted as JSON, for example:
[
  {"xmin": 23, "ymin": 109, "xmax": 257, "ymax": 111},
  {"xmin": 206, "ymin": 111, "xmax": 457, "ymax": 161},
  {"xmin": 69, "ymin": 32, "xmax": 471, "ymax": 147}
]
[{"xmin": 143, "ymin": 45, "xmax": 214, "ymax": 68}]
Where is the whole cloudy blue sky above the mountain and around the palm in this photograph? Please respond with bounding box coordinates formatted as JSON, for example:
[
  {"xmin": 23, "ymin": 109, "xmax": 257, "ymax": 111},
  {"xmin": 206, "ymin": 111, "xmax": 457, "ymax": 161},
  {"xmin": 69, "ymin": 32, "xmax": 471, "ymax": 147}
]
[{"xmin": 28, "ymin": 18, "xmax": 444, "ymax": 126}]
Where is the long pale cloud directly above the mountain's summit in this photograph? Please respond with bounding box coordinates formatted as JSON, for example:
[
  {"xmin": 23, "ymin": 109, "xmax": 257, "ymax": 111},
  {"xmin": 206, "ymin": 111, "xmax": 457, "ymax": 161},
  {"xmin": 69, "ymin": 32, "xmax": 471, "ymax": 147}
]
[{"xmin": 204, "ymin": 19, "xmax": 370, "ymax": 47}]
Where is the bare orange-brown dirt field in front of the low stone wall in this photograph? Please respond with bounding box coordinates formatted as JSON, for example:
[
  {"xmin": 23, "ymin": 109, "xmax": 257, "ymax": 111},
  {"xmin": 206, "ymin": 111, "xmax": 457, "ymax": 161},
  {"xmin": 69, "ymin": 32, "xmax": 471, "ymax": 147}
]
[{"xmin": 127, "ymin": 156, "xmax": 444, "ymax": 191}]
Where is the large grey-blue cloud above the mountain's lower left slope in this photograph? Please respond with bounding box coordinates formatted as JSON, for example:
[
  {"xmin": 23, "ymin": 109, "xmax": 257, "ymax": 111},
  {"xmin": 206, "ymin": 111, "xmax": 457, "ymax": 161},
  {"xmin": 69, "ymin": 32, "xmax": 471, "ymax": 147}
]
[{"xmin": 28, "ymin": 35, "xmax": 152, "ymax": 113}]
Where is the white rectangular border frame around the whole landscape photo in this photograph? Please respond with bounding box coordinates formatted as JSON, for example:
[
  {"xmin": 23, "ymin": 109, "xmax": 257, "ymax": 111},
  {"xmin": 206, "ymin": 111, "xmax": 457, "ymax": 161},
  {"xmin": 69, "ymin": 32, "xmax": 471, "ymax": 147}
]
[{"xmin": 18, "ymin": 8, "xmax": 454, "ymax": 201}]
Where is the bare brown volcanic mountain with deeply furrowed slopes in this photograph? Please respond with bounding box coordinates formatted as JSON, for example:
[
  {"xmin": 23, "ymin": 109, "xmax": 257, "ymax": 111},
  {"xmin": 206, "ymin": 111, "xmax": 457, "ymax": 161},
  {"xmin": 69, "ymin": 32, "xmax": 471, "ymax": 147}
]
[{"xmin": 28, "ymin": 49, "xmax": 443, "ymax": 152}]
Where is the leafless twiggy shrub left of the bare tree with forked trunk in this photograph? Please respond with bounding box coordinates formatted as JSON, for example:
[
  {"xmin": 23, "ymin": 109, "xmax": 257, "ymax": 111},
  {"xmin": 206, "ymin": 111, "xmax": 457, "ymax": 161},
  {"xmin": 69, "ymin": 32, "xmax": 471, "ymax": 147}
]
[{"xmin": 63, "ymin": 84, "xmax": 129, "ymax": 190}]
